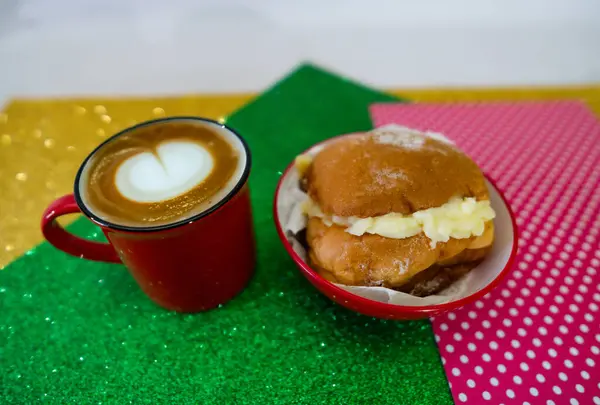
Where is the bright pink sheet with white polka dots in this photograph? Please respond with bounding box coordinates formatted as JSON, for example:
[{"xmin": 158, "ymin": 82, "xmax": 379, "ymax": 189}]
[{"xmin": 371, "ymin": 102, "xmax": 600, "ymax": 405}]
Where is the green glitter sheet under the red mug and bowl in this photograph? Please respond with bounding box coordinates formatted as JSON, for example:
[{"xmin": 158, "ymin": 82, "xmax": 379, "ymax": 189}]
[{"xmin": 0, "ymin": 66, "xmax": 452, "ymax": 405}]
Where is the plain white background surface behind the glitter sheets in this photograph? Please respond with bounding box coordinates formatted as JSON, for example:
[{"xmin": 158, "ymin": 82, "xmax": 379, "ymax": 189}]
[{"xmin": 0, "ymin": 0, "xmax": 600, "ymax": 103}]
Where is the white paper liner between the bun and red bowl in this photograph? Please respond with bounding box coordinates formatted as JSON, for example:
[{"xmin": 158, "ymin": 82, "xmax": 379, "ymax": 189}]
[{"xmin": 276, "ymin": 126, "xmax": 515, "ymax": 306}]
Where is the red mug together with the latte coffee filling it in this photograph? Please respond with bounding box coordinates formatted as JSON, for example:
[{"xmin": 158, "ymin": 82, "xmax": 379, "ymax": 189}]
[{"xmin": 41, "ymin": 117, "xmax": 256, "ymax": 312}]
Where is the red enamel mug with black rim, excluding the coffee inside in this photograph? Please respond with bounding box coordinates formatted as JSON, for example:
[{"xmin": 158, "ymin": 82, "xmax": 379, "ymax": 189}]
[{"xmin": 41, "ymin": 117, "xmax": 255, "ymax": 312}]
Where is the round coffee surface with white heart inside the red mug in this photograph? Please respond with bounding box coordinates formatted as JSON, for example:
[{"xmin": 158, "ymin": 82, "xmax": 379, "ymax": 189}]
[{"xmin": 78, "ymin": 119, "xmax": 246, "ymax": 227}]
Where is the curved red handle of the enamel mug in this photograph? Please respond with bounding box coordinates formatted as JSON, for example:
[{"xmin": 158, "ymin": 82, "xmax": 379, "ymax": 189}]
[{"xmin": 42, "ymin": 194, "xmax": 121, "ymax": 263}]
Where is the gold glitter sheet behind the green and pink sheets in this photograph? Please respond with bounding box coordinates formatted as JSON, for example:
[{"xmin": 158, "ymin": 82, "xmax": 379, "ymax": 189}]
[{"xmin": 0, "ymin": 86, "xmax": 600, "ymax": 269}]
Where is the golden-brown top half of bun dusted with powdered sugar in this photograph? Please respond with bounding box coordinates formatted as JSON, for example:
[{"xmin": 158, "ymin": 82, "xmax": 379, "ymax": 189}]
[{"xmin": 305, "ymin": 132, "xmax": 489, "ymax": 217}]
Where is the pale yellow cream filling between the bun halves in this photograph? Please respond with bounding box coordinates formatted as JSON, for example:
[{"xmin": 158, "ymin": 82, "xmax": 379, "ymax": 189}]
[{"xmin": 302, "ymin": 197, "xmax": 496, "ymax": 247}]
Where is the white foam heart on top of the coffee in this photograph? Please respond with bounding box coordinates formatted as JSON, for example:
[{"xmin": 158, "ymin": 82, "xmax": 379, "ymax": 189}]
[{"xmin": 115, "ymin": 141, "xmax": 214, "ymax": 203}]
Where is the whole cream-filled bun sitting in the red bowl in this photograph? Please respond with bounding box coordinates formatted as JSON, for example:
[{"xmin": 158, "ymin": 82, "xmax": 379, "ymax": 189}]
[{"xmin": 296, "ymin": 129, "xmax": 495, "ymax": 296}]
